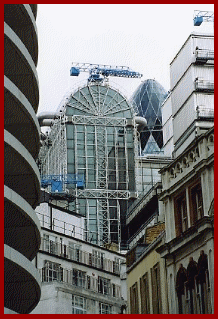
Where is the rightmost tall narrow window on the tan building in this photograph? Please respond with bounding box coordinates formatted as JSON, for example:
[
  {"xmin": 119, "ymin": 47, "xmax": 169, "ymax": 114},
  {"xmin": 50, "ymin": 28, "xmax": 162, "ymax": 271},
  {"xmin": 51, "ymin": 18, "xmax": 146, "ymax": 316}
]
[{"xmin": 151, "ymin": 263, "xmax": 162, "ymax": 314}]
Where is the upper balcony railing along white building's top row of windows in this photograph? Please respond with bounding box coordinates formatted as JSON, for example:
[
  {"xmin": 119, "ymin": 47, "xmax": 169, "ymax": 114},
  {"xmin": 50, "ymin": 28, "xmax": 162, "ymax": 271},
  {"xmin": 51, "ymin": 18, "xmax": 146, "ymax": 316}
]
[{"xmin": 40, "ymin": 238, "xmax": 120, "ymax": 275}]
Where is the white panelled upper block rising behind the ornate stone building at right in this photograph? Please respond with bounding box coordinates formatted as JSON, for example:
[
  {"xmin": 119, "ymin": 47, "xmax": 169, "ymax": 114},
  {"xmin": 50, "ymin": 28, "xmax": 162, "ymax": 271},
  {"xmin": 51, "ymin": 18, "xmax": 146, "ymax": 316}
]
[{"xmin": 162, "ymin": 32, "xmax": 214, "ymax": 157}]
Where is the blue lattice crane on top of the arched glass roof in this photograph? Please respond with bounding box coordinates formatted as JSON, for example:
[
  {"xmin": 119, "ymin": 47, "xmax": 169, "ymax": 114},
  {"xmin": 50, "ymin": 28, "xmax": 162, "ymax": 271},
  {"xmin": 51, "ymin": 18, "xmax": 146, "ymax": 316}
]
[{"xmin": 70, "ymin": 62, "xmax": 142, "ymax": 82}]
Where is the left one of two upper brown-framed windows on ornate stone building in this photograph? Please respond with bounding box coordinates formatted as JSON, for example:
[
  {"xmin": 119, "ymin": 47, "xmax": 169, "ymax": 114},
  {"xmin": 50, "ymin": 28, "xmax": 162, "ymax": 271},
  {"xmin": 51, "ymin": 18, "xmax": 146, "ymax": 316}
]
[{"xmin": 175, "ymin": 192, "xmax": 188, "ymax": 236}]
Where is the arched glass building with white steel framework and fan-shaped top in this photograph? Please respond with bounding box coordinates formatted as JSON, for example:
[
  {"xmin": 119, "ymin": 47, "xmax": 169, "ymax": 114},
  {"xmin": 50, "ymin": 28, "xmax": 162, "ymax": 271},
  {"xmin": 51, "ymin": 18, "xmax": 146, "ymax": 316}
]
[{"xmin": 39, "ymin": 83, "xmax": 139, "ymax": 247}]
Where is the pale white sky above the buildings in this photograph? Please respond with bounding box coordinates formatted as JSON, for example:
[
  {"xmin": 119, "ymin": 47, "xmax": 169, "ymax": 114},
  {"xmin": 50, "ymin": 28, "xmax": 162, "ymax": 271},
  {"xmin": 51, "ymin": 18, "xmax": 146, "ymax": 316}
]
[{"xmin": 36, "ymin": 4, "xmax": 214, "ymax": 113}]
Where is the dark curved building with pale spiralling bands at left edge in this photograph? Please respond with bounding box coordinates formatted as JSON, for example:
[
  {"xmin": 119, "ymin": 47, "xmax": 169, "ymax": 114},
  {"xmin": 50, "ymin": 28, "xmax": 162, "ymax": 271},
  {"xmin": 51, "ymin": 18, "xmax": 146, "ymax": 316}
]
[{"xmin": 4, "ymin": 4, "xmax": 41, "ymax": 314}]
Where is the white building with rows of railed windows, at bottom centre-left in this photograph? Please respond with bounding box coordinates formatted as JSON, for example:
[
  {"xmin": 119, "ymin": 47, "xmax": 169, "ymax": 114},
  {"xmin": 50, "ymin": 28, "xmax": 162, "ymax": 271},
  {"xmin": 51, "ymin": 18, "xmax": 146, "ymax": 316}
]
[{"xmin": 32, "ymin": 199, "xmax": 127, "ymax": 314}]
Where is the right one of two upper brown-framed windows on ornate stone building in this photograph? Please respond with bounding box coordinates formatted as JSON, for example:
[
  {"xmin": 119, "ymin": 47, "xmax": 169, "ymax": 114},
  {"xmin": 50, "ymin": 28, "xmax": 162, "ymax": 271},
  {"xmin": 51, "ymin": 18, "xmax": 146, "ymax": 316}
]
[{"xmin": 189, "ymin": 182, "xmax": 204, "ymax": 225}]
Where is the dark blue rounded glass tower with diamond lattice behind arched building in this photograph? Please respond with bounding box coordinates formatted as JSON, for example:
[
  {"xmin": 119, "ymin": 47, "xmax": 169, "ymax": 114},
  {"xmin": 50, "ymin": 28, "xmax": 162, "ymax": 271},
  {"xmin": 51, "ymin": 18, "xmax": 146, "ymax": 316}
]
[{"xmin": 131, "ymin": 79, "xmax": 167, "ymax": 154}]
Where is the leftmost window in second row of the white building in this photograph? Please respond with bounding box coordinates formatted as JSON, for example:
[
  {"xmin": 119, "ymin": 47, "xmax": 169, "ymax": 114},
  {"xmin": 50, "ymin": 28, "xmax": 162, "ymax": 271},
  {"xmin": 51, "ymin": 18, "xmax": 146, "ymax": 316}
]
[{"xmin": 42, "ymin": 260, "xmax": 63, "ymax": 282}]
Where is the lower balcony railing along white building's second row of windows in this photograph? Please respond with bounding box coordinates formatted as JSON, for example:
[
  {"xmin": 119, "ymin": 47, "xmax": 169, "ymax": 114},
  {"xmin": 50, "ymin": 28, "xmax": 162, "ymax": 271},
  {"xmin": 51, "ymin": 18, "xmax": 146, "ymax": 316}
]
[{"xmin": 38, "ymin": 266, "xmax": 121, "ymax": 299}]
